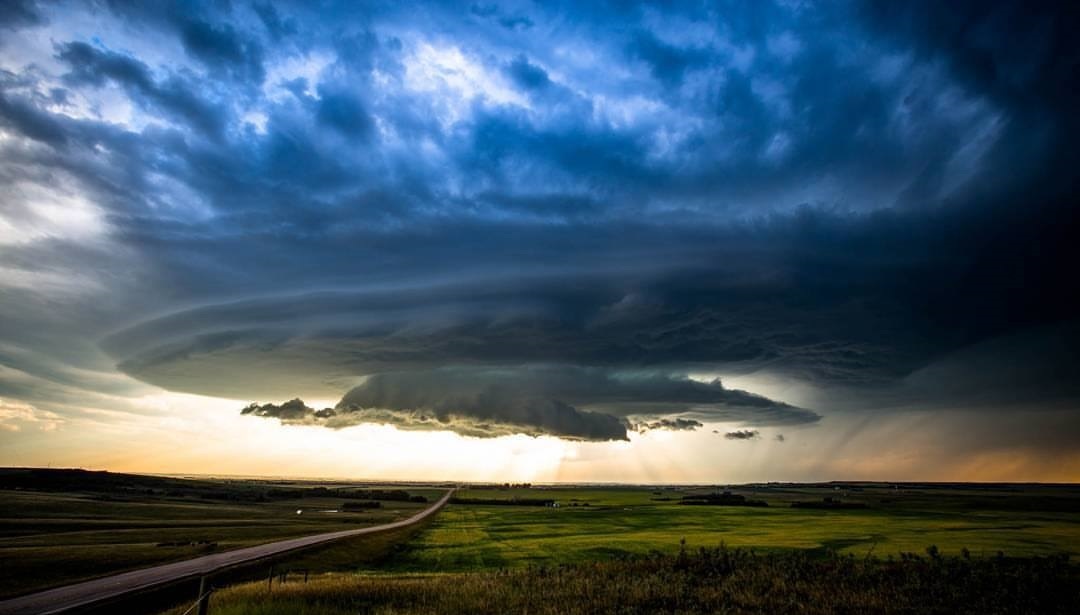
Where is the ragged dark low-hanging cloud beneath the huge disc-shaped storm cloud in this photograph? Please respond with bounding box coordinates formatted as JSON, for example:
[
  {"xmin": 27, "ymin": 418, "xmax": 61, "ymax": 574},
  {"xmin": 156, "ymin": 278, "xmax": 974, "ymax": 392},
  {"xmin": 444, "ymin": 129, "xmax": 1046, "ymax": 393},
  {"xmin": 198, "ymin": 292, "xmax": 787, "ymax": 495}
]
[{"xmin": 243, "ymin": 366, "xmax": 818, "ymax": 441}]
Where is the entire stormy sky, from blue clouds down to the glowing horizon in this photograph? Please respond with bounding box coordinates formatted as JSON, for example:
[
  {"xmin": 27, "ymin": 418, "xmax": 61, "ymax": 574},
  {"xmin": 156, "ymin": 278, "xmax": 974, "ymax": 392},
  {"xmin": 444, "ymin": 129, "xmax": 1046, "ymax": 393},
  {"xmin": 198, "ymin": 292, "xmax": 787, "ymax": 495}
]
[{"xmin": 0, "ymin": 0, "xmax": 1080, "ymax": 483}]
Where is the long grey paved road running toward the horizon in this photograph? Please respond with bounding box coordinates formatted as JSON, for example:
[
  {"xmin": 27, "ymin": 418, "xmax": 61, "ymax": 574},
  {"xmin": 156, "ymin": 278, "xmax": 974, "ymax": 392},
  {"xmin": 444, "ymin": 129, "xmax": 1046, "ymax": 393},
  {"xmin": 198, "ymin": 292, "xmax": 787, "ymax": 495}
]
[{"xmin": 0, "ymin": 490, "xmax": 454, "ymax": 615}]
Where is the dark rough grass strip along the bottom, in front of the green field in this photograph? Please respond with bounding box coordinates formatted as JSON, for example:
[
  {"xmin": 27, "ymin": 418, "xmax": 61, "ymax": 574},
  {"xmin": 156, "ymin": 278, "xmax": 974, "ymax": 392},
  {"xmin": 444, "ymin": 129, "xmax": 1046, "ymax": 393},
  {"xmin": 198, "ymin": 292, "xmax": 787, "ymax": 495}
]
[{"xmin": 164, "ymin": 547, "xmax": 1080, "ymax": 615}]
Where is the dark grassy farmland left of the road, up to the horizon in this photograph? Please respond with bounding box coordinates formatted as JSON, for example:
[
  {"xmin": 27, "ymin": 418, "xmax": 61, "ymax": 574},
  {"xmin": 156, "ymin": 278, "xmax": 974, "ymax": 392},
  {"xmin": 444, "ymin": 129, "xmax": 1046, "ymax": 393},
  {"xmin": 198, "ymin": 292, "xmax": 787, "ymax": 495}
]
[{"xmin": 0, "ymin": 470, "xmax": 444, "ymax": 598}]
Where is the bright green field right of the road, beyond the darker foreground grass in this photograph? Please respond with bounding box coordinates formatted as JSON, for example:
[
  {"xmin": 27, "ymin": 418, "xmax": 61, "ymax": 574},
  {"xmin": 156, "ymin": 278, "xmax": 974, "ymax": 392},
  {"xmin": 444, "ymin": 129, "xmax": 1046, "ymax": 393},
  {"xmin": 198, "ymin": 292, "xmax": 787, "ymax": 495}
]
[{"xmin": 390, "ymin": 483, "xmax": 1080, "ymax": 572}]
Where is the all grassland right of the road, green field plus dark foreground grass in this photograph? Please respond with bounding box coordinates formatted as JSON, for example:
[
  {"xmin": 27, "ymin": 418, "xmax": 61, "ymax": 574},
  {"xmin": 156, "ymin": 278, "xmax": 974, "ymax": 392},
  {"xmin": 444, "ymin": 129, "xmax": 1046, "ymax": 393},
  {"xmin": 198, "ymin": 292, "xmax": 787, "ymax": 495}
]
[{"xmin": 168, "ymin": 483, "xmax": 1080, "ymax": 615}]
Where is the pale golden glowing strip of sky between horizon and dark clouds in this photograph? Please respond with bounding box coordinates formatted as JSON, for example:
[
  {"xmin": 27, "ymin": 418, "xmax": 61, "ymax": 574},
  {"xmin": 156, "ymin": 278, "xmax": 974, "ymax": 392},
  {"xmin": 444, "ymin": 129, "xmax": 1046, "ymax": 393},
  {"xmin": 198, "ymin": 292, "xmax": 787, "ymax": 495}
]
[{"xmin": 0, "ymin": 392, "xmax": 1080, "ymax": 484}]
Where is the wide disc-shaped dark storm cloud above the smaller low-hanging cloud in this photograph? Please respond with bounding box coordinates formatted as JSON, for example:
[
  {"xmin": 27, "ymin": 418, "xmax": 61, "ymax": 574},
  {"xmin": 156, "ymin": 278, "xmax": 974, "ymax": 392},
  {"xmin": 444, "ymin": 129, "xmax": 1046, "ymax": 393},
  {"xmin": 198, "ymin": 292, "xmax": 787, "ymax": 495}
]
[{"xmin": 95, "ymin": 251, "xmax": 932, "ymax": 399}]
